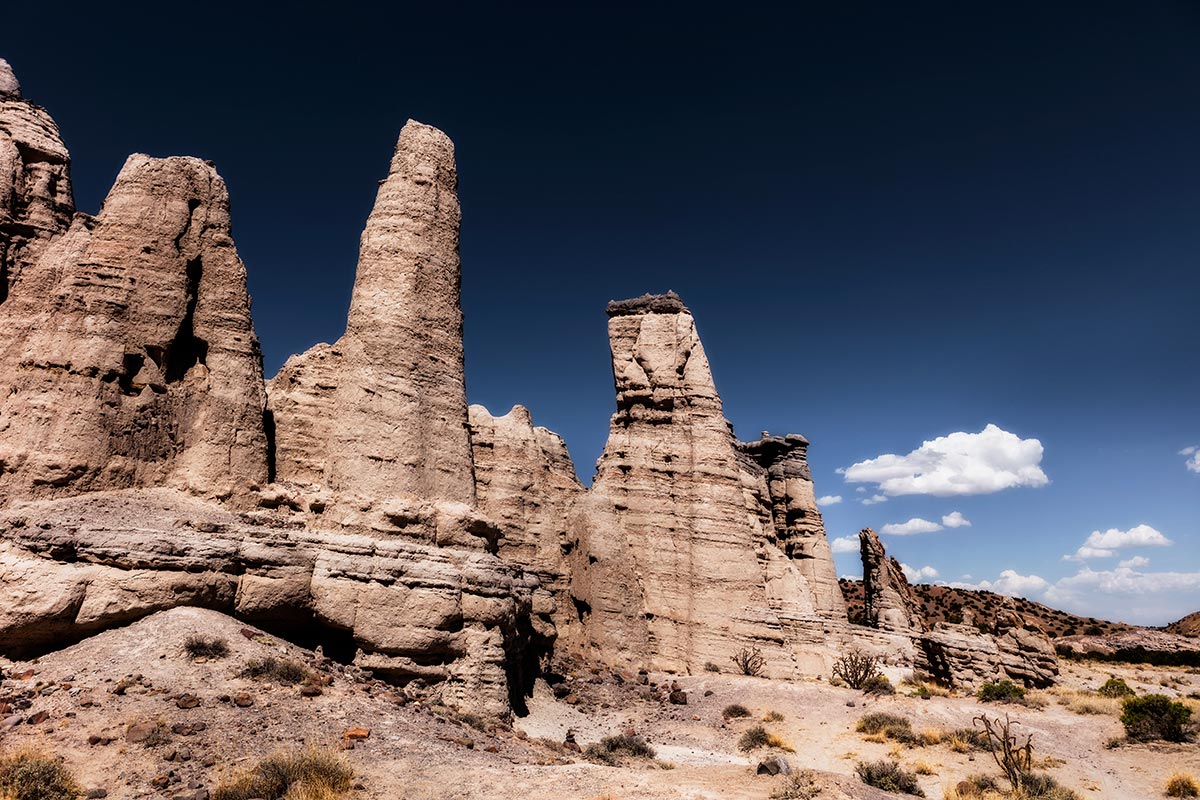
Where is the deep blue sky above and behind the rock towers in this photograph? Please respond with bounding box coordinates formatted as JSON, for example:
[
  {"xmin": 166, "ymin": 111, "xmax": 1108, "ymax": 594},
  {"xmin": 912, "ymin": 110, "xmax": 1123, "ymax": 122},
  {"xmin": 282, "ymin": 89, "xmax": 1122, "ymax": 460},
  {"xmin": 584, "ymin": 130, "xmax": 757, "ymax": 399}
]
[{"xmin": 0, "ymin": 2, "xmax": 1200, "ymax": 622}]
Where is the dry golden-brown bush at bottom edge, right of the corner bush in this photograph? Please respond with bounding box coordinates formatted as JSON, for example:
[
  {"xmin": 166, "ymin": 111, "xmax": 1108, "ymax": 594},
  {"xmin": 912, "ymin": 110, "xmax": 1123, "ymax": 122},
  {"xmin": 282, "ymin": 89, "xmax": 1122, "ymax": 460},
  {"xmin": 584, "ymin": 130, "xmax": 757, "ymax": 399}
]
[{"xmin": 212, "ymin": 750, "xmax": 354, "ymax": 800}]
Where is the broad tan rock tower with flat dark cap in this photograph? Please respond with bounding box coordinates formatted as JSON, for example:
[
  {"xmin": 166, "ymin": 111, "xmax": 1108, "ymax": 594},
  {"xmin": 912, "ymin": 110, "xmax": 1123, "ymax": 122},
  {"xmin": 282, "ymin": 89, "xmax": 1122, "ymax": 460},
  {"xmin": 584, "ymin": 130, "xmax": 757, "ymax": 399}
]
[{"xmin": 569, "ymin": 294, "xmax": 844, "ymax": 675}]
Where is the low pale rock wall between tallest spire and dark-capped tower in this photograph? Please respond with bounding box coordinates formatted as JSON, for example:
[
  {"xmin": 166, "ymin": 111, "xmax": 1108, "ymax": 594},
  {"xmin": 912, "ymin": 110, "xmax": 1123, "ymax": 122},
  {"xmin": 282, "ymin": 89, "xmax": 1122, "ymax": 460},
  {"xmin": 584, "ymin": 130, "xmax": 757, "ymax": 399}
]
[{"xmin": 470, "ymin": 405, "xmax": 584, "ymax": 648}]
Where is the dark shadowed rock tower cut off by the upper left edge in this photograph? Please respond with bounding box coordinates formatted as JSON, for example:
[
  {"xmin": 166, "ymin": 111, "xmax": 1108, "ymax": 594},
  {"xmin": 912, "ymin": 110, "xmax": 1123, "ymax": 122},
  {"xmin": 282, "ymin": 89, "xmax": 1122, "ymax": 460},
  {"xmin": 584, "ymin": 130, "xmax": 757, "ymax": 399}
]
[{"xmin": 0, "ymin": 59, "xmax": 74, "ymax": 303}]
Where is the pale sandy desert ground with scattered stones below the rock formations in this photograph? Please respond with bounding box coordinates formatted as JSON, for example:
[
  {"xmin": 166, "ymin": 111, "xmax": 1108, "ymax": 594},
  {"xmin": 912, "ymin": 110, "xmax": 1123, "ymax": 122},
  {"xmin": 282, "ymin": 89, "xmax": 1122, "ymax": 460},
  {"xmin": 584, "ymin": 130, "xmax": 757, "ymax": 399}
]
[{"xmin": 0, "ymin": 608, "xmax": 1200, "ymax": 800}]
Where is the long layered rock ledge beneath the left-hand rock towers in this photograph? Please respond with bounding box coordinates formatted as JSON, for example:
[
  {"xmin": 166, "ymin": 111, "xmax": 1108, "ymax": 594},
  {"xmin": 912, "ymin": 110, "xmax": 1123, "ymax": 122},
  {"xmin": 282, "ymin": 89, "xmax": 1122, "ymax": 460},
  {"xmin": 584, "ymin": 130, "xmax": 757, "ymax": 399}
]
[{"xmin": 0, "ymin": 489, "xmax": 534, "ymax": 715}]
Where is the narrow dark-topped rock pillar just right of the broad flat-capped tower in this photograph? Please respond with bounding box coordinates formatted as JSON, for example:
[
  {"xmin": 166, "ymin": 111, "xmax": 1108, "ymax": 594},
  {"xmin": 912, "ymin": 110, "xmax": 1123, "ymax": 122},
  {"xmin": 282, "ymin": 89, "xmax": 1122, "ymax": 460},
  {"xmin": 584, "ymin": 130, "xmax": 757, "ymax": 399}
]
[{"xmin": 740, "ymin": 433, "xmax": 846, "ymax": 620}]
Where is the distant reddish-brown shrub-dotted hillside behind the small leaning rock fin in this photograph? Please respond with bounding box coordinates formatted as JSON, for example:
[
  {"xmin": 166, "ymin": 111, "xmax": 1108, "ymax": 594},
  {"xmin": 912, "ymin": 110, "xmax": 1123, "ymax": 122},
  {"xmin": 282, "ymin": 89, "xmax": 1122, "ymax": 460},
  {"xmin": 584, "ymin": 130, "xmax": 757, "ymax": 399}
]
[{"xmin": 838, "ymin": 578, "xmax": 1132, "ymax": 638}]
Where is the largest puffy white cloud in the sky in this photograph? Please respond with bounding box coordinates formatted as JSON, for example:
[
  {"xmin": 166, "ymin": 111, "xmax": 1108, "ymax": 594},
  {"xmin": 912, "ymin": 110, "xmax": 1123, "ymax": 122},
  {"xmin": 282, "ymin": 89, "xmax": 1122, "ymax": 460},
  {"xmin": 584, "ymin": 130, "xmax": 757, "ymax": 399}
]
[{"xmin": 838, "ymin": 425, "xmax": 1050, "ymax": 497}]
